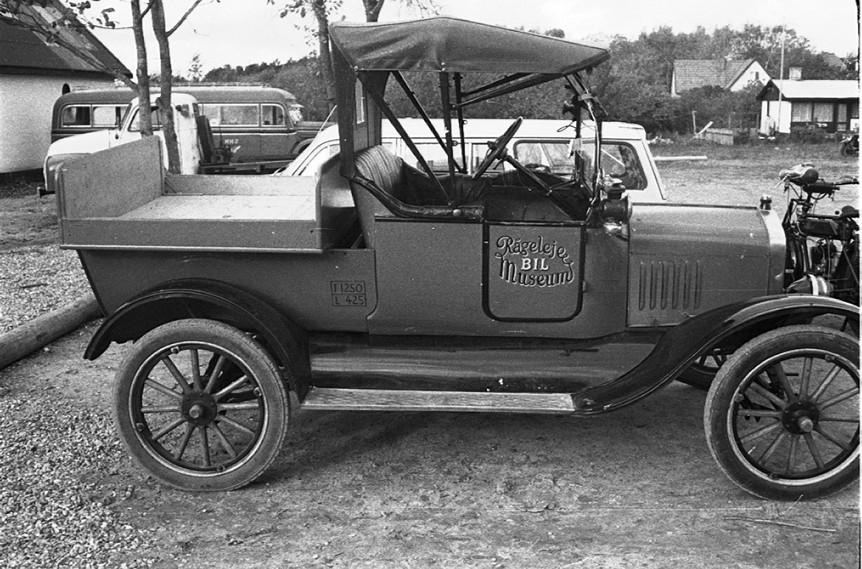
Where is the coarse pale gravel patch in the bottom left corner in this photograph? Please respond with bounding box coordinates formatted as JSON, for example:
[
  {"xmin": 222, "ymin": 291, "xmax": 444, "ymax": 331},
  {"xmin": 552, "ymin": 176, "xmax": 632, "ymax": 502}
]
[{"xmin": 0, "ymin": 393, "xmax": 151, "ymax": 568}]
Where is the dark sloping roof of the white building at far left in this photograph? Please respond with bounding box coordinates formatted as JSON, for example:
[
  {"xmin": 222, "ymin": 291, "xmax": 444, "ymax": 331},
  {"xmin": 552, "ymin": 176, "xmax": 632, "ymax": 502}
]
[{"xmin": 0, "ymin": 0, "xmax": 131, "ymax": 76}]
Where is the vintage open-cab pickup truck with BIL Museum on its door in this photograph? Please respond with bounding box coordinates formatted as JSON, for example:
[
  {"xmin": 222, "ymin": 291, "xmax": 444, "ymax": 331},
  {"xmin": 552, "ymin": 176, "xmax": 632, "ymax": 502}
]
[{"xmin": 58, "ymin": 18, "xmax": 859, "ymax": 499}]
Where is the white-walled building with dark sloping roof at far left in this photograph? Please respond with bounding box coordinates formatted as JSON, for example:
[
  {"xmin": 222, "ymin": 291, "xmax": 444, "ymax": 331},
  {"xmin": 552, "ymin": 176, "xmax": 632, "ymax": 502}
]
[{"xmin": 0, "ymin": 0, "xmax": 131, "ymax": 174}]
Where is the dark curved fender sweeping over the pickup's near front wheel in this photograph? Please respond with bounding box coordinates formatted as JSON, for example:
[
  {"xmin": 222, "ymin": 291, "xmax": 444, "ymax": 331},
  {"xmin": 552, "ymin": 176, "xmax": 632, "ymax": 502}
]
[{"xmin": 572, "ymin": 295, "xmax": 859, "ymax": 415}]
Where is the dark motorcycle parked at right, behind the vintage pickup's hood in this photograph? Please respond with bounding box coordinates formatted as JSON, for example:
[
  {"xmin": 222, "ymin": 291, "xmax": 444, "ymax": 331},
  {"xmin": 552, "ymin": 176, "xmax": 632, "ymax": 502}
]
[{"xmin": 780, "ymin": 164, "xmax": 859, "ymax": 306}]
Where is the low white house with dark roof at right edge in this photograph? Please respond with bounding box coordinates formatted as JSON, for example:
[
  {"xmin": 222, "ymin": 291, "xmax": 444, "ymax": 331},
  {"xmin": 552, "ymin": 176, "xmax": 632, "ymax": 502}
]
[{"xmin": 757, "ymin": 79, "xmax": 859, "ymax": 135}]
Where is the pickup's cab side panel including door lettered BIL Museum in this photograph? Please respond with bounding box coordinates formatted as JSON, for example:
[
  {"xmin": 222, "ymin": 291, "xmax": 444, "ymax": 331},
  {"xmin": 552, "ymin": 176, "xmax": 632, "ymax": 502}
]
[{"xmin": 368, "ymin": 188, "xmax": 585, "ymax": 335}]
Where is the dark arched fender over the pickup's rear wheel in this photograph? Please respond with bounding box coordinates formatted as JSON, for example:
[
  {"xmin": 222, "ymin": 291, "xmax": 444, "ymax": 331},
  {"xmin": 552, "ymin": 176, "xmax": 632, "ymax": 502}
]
[{"xmin": 84, "ymin": 280, "xmax": 311, "ymax": 397}]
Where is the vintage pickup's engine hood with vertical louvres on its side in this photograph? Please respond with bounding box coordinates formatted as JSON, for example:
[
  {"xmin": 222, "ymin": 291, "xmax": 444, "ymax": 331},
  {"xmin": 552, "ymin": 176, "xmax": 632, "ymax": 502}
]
[{"xmin": 628, "ymin": 204, "xmax": 784, "ymax": 326}]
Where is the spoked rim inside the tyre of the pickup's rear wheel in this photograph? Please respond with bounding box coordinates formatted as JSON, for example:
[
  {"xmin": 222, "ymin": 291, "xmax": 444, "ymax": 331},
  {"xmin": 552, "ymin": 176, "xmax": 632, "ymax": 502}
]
[{"xmin": 128, "ymin": 342, "xmax": 268, "ymax": 477}]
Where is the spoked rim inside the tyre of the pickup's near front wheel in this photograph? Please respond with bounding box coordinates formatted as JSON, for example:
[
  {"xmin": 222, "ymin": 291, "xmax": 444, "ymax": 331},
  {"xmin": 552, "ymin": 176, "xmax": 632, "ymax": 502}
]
[{"xmin": 727, "ymin": 349, "xmax": 859, "ymax": 486}]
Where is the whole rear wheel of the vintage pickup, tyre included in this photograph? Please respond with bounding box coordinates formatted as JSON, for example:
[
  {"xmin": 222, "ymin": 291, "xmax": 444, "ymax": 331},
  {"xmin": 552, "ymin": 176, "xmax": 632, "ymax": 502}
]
[{"xmin": 114, "ymin": 319, "xmax": 290, "ymax": 491}]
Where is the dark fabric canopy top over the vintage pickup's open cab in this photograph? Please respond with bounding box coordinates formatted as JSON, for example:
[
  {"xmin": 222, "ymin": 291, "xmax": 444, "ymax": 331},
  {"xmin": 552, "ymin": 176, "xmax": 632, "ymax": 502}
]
[{"xmin": 329, "ymin": 17, "xmax": 609, "ymax": 75}]
